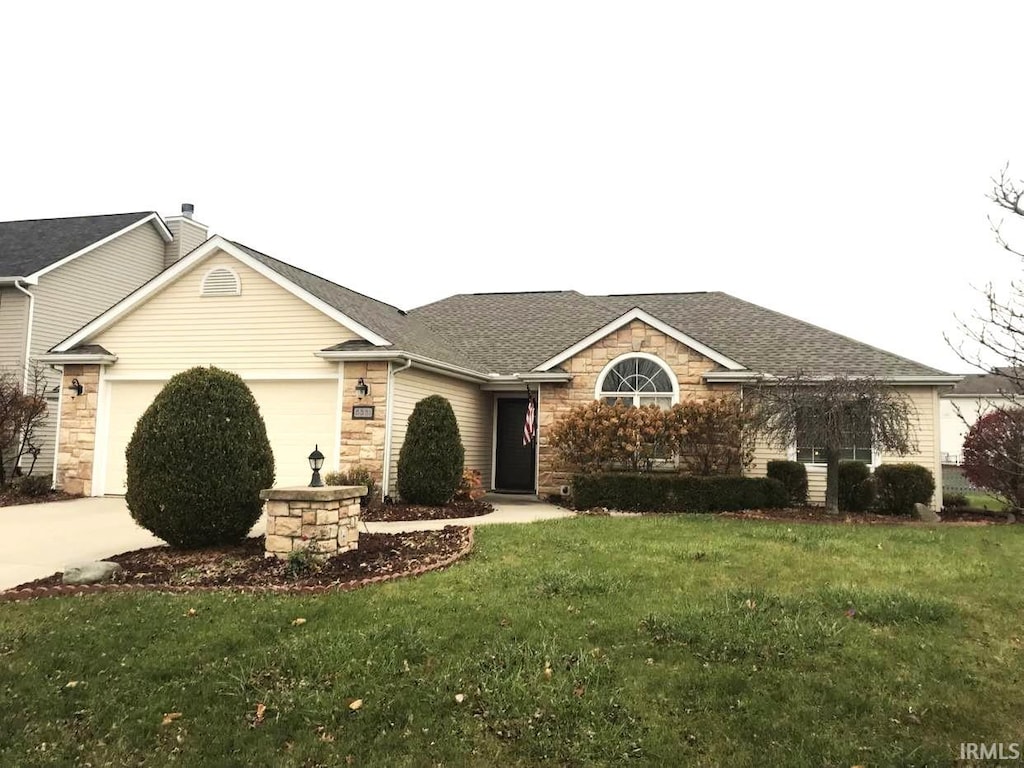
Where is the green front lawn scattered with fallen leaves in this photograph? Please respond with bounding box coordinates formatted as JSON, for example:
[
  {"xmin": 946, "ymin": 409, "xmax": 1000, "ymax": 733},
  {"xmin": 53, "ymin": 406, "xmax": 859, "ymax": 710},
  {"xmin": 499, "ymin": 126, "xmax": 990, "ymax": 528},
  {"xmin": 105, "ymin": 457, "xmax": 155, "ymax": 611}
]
[{"xmin": 0, "ymin": 517, "xmax": 1024, "ymax": 768}]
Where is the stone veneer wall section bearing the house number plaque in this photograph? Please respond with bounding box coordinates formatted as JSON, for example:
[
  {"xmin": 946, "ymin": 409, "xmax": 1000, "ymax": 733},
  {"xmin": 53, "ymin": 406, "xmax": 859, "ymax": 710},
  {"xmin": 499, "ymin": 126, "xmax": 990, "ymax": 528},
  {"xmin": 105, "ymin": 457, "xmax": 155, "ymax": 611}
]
[{"xmin": 339, "ymin": 360, "xmax": 388, "ymax": 487}]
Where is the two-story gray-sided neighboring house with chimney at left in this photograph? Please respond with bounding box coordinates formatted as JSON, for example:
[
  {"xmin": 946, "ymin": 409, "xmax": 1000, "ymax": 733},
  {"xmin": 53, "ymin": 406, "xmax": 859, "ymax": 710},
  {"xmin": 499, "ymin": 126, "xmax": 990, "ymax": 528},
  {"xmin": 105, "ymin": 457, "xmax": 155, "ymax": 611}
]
[{"xmin": 0, "ymin": 205, "xmax": 207, "ymax": 481}]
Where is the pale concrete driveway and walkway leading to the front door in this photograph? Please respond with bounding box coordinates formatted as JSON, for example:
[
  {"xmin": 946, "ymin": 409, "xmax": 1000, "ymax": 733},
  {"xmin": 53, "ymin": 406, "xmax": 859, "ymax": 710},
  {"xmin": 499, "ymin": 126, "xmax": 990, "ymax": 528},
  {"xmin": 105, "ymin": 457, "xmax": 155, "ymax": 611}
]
[{"xmin": 0, "ymin": 494, "xmax": 572, "ymax": 590}]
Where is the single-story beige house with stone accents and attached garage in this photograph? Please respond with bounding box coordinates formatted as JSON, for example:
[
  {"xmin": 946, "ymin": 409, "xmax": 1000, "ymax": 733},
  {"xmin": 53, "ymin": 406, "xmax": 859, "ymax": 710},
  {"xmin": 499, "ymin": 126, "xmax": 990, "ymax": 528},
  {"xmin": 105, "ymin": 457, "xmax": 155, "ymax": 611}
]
[{"xmin": 44, "ymin": 237, "xmax": 959, "ymax": 507}]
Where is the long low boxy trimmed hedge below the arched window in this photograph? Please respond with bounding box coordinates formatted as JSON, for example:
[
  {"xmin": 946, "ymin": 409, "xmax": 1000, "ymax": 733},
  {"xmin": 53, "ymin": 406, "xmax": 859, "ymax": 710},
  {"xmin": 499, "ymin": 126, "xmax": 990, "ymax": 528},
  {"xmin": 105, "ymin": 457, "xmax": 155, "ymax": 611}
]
[{"xmin": 572, "ymin": 472, "xmax": 788, "ymax": 512}]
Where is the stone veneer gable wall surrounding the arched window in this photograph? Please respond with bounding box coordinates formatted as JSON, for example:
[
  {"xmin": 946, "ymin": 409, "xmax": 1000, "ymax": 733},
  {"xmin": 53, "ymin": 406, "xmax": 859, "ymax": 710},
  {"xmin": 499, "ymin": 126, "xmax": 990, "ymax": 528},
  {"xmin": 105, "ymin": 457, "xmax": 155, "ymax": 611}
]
[{"xmin": 538, "ymin": 319, "xmax": 735, "ymax": 495}]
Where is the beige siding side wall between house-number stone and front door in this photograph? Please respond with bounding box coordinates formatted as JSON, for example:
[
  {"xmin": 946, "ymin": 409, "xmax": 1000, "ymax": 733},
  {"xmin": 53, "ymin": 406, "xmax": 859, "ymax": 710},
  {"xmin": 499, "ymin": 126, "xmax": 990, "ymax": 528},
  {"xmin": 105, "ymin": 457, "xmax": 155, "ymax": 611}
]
[{"xmin": 388, "ymin": 368, "xmax": 494, "ymax": 494}]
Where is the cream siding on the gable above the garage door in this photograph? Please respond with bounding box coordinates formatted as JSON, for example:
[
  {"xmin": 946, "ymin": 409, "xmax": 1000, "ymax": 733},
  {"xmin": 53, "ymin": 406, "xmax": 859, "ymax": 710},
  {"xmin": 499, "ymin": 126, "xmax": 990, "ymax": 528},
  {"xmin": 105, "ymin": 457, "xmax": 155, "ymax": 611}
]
[{"xmin": 90, "ymin": 252, "xmax": 358, "ymax": 378}]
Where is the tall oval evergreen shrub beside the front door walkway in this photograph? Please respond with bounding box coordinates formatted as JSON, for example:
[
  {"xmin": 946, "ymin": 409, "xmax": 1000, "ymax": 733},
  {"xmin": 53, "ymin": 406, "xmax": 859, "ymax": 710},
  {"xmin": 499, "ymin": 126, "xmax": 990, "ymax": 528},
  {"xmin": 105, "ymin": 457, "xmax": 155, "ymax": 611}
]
[{"xmin": 396, "ymin": 394, "xmax": 466, "ymax": 506}]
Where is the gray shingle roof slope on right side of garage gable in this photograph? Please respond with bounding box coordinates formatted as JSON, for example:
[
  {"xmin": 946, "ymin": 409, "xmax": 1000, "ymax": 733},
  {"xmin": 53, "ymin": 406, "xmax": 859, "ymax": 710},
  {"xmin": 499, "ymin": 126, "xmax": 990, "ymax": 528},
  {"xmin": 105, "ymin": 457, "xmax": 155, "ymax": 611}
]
[{"xmin": 232, "ymin": 242, "xmax": 482, "ymax": 372}]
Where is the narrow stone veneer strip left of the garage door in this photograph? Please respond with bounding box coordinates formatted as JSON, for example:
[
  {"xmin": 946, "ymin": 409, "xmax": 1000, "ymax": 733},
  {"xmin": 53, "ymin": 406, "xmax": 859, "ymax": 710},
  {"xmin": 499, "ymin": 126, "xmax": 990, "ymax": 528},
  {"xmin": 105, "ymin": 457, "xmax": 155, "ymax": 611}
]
[{"xmin": 56, "ymin": 366, "xmax": 99, "ymax": 496}]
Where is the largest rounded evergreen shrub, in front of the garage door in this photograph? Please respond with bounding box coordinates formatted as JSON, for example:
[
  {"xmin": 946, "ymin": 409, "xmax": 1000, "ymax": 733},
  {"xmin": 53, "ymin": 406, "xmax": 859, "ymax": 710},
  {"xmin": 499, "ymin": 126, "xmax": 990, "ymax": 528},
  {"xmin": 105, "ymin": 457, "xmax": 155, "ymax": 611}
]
[{"xmin": 125, "ymin": 368, "xmax": 274, "ymax": 548}]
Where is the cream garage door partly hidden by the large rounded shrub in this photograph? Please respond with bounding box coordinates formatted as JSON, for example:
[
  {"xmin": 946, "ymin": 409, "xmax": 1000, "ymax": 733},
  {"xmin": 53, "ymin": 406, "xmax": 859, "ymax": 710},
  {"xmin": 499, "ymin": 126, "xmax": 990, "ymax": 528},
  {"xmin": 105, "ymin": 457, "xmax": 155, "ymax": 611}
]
[{"xmin": 102, "ymin": 379, "xmax": 338, "ymax": 494}]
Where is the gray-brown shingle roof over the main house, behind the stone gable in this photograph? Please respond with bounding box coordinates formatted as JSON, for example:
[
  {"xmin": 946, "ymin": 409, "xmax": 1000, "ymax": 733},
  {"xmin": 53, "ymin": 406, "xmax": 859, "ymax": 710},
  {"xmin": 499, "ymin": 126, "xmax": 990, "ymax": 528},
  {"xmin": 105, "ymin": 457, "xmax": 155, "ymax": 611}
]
[{"xmin": 410, "ymin": 291, "xmax": 943, "ymax": 376}]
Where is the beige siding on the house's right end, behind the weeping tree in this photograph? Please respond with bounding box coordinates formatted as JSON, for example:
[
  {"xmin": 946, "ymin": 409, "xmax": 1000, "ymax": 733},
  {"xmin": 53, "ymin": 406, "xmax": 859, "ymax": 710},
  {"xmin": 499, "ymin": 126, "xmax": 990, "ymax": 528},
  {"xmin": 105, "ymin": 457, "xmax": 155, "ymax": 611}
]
[{"xmin": 748, "ymin": 386, "xmax": 942, "ymax": 506}]
